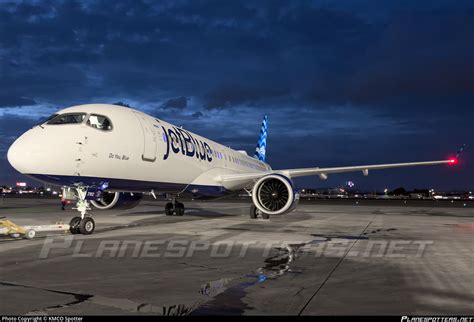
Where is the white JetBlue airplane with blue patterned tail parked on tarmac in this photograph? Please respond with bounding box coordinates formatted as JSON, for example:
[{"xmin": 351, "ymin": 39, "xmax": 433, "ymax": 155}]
[{"xmin": 7, "ymin": 104, "xmax": 458, "ymax": 235}]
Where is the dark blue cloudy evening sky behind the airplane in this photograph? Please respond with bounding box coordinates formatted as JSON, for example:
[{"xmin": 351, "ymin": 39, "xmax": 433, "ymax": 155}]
[{"xmin": 0, "ymin": 0, "xmax": 474, "ymax": 189}]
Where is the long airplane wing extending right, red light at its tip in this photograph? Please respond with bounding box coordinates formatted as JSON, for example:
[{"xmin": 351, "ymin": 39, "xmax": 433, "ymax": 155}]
[{"xmin": 217, "ymin": 158, "xmax": 457, "ymax": 189}]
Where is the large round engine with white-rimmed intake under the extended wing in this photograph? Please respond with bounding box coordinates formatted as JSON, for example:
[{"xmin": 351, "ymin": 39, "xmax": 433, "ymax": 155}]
[{"xmin": 252, "ymin": 174, "xmax": 299, "ymax": 215}]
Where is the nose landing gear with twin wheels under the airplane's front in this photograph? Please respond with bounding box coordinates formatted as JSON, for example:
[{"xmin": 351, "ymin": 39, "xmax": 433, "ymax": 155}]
[{"xmin": 67, "ymin": 187, "xmax": 95, "ymax": 235}]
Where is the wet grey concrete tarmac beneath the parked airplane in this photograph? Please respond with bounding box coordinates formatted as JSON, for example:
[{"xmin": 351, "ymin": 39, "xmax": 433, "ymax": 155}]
[{"xmin": 0, "ymin": 198, "xmax": 474, "ymax": 315}]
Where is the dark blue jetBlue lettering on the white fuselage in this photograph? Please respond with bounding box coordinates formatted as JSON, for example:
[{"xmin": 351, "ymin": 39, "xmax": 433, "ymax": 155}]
[{"xmin": 161, "ymin": 126, "xmax": 212, "ymax": 162}]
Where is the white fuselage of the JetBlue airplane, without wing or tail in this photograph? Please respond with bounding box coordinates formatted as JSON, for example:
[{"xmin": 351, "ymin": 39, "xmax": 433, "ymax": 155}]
[{"xmin": 8, "ymin": 104, "xmax": 271, "ymax": 196}]
